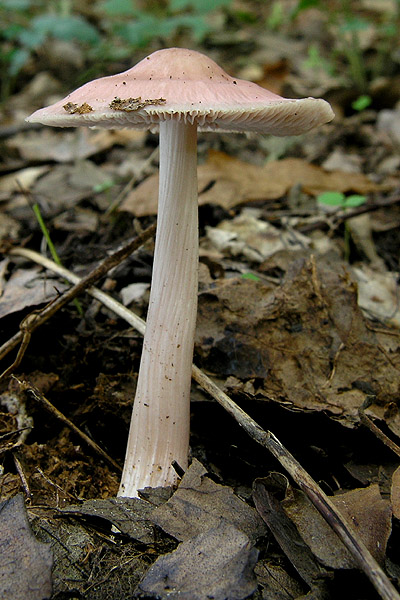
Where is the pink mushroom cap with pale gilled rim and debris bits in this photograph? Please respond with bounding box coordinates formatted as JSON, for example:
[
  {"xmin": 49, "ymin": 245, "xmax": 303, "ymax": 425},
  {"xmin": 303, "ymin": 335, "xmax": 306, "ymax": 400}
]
[{"xmin": 26, "ymin": 48, "xmax": 334, "ymax": 136}]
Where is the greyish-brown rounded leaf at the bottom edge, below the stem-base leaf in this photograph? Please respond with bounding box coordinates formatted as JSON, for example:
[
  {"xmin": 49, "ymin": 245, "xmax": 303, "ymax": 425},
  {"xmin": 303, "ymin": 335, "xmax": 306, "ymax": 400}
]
[{"xmin": 135, "ymin": 521, "xmax": 258, "ymax": 600}]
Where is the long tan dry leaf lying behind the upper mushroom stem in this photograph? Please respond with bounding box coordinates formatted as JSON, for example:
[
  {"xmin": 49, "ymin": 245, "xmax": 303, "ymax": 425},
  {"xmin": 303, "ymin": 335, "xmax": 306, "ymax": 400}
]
[{"xmin": 121, "ymin": 151, "xmax": 380, "ymax": 217}]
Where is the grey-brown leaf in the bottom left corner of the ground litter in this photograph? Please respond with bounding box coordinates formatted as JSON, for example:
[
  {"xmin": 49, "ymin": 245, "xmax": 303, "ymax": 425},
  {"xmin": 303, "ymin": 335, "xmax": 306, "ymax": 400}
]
[{"xmin": 0, "ymin": 494, "xmax": 53, "ymax": 600}]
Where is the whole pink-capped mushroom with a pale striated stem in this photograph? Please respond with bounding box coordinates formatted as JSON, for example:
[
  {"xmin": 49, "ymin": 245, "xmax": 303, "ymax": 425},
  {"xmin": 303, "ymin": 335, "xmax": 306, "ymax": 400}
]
[{"xmin": 27, "ymin": 48, "xmax": 333, "ymax": 497}]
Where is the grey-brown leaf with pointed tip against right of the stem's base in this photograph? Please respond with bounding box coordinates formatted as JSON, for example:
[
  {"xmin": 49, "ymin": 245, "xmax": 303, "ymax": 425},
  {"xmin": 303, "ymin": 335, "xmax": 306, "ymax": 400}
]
[{"xmin": 150, "ymin": 459, "xmax": 265, "ymax": 541}]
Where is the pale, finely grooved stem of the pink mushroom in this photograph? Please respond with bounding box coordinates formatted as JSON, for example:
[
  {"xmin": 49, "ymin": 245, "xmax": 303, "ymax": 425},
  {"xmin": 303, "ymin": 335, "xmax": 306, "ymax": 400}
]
[{"xmin": 118, "ymin": 120, "xmax": 198, "ymax": 497}]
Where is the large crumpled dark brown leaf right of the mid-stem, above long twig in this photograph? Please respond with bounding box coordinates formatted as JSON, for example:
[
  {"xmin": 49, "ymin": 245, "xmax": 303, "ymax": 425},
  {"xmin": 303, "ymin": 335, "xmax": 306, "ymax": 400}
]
[{"xmin": 196, "ymin": 257, "xmax": 400, "ymax": 426}]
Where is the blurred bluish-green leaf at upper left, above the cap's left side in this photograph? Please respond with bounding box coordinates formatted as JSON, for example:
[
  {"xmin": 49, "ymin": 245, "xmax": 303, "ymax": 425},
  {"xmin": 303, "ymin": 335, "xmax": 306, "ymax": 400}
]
[{"xmin": 32, "ymin": 14, "xmax": 100, "ymax": 44}]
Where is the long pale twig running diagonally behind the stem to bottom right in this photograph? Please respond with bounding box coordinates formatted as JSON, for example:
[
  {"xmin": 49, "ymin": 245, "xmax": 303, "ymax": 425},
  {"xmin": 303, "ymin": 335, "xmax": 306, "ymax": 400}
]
[{"xmin": 1, "ymin": 252, "xmax": 400, "ymax": 600}]
